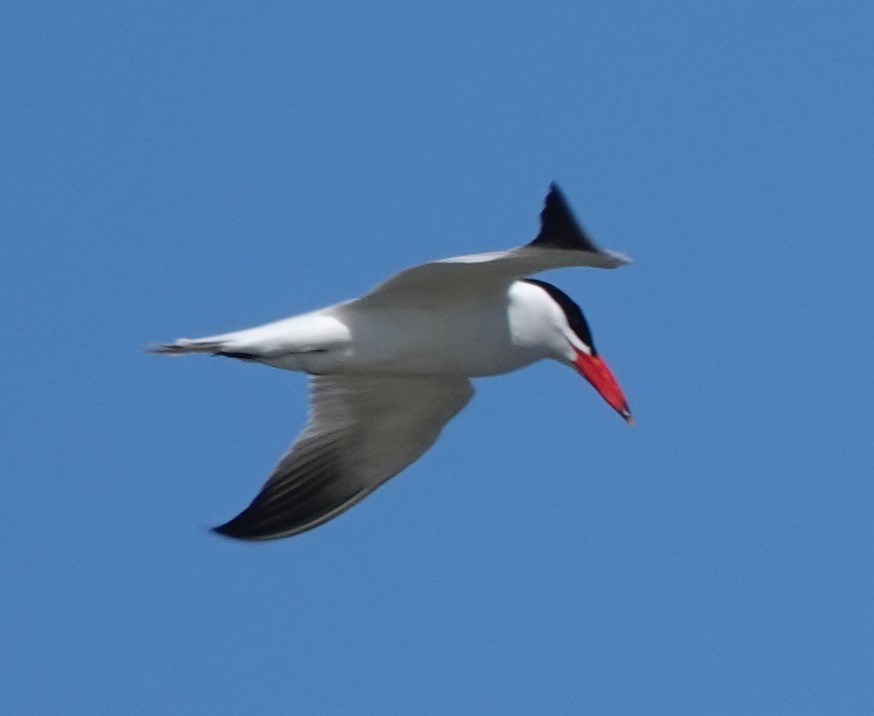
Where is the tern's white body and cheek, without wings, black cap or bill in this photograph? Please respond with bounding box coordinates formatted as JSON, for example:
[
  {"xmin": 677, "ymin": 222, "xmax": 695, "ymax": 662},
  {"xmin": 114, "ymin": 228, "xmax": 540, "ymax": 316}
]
[{"xmin": 200, "ymin": 281, "xmax": 573, "ymax": 377}]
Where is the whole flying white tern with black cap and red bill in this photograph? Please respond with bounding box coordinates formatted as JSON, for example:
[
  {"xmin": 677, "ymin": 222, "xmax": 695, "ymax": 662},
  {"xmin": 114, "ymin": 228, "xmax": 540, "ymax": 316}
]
[{"xmin": 150, "ymin": 184, "xmax": 631, "ymax": 540}]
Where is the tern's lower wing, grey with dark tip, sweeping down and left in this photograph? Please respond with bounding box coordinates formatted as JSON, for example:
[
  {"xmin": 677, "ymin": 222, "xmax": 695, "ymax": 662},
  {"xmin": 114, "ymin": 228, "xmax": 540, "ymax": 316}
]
[{"xmin": 215, "ymin": 376, "xmax": 473, "ymax": 540}]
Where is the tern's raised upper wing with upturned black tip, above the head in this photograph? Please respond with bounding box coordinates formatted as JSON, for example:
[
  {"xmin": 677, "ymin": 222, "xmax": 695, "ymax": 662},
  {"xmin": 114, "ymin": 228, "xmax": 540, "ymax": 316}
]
[{"xmin": 359, "ymin": 184, "xmax": 629, "ymax": 305}]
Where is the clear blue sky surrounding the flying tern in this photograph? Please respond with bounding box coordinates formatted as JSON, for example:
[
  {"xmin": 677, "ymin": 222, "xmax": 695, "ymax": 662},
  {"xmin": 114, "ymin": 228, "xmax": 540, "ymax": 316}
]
[{"xmin": 0, "ymin": 0, "xmax": 874, "ymax": 715}]
